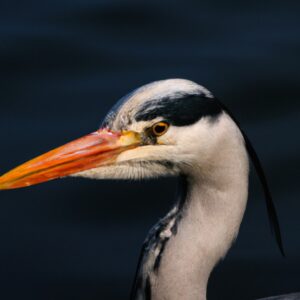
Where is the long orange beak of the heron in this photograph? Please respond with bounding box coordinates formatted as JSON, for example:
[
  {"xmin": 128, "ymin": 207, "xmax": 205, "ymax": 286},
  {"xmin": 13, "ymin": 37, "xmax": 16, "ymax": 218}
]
[{"xmin": 0, "ymin": 129, "xmax": 140, "ymax": 190}]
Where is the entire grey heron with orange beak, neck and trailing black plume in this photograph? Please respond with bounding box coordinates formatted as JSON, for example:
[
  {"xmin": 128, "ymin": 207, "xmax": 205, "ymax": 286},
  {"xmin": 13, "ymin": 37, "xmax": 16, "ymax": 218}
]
[{"xmin": 0, "ymin": 79, "xmax": 296, "ymax": 300}]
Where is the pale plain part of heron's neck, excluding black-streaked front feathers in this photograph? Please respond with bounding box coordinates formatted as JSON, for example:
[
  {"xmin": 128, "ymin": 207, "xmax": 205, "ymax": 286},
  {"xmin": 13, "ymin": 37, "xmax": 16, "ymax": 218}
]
[{"xmin": 151, "ymin": 136, "xmax": 248, "ymax": 300}]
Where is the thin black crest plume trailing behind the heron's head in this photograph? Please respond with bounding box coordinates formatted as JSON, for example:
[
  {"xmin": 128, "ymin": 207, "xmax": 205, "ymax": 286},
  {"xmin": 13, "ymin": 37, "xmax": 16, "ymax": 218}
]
[{"xmin": 216, "ymin": 99, "xmax": 285, "ymax": 256}]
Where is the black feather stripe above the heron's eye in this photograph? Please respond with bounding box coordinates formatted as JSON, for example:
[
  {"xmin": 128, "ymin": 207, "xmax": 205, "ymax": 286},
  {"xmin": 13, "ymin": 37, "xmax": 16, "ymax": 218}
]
[{"xmin": 135, "ymin": 95, "xmax": 222, "ymax": 126}]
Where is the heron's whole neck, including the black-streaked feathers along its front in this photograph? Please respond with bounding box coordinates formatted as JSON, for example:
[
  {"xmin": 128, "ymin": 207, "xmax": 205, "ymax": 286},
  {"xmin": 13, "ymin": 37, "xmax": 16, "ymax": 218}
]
[{"xmin": 132, "ymin": 127, "xmax": 248, "ymax": 300}]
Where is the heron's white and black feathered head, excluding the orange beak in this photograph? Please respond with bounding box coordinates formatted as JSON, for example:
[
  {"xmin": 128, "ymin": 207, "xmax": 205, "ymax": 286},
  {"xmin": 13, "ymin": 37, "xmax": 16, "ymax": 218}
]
[{"xmin": 81, "ymin": 79, "xmax": 236, "ymax": 179}]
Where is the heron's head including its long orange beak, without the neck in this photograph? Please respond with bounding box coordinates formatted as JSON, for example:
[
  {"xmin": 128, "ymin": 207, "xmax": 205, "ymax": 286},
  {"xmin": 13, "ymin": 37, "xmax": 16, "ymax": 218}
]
[{"xmin": 0, "ymin": 79, "xmax": 239, "ymax": 189}]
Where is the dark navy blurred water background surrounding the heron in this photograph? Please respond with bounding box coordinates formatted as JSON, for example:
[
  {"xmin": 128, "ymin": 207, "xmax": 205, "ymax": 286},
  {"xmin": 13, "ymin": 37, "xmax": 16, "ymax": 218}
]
[{"xmin": 0, "ymin": 0, "xmax": 300, "ymax": 300}]
